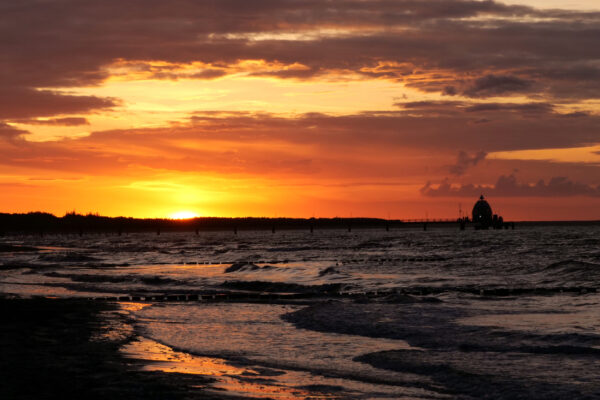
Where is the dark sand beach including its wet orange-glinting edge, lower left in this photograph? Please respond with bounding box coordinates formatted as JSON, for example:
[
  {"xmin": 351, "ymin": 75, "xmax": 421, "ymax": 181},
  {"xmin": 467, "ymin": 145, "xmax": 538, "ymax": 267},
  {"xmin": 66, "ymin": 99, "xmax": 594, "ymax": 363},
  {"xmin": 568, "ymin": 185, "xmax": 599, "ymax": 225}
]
[{"xmin": 0, "ymin": 297, "xmax": 422, "ymax": 400}]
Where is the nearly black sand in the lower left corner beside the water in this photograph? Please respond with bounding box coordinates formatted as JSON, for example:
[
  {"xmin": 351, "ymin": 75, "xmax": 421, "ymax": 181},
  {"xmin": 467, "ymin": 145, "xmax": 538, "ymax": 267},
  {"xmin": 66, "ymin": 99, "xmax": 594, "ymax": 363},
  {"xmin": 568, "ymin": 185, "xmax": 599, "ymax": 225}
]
[{"xmin": 0, "ymin": 299, "xmax": 244, "ymax": 400}]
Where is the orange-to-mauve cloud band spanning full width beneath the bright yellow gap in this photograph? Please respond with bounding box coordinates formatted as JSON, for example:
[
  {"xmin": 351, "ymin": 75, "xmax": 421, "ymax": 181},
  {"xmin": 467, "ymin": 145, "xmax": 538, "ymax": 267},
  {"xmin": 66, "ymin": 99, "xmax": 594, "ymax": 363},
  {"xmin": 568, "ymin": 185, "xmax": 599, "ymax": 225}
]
[{"xmin": 0, "ymin": 109, "xmax": 600, "ymax": 178}]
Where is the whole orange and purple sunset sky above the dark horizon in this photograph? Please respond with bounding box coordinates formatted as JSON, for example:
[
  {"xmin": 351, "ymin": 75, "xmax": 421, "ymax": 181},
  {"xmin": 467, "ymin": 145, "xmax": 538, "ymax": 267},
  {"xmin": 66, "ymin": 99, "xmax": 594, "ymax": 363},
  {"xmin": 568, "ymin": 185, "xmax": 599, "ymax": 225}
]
[{"xmin": 0, "ymin": 0, "xmax": 600, "ymax": 220}]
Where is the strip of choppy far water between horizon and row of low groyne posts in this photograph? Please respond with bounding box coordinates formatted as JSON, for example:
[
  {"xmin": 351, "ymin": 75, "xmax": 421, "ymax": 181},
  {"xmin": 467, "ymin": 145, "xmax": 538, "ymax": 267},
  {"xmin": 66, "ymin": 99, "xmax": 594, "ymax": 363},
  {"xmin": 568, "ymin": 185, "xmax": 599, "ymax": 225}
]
[{"xmin": 0, "ymin": 227, "xmax": 600, "ymax": 292}]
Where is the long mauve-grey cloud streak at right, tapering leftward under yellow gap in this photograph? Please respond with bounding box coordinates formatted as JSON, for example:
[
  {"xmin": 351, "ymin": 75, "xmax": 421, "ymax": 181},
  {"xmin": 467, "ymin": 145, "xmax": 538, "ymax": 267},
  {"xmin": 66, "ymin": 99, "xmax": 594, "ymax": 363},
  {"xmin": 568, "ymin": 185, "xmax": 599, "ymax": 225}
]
[{"xmin": 193, "ymin": 105, "xmax": 600, "ymax": 152}]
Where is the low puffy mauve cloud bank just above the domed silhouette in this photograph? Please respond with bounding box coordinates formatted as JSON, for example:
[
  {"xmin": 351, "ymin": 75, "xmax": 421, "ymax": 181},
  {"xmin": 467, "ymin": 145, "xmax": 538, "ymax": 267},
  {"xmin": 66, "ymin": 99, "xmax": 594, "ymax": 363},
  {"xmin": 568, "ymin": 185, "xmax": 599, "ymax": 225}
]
[{"xmin": 421, "ymin": 174, "xmax": 600, "ymax": 197}]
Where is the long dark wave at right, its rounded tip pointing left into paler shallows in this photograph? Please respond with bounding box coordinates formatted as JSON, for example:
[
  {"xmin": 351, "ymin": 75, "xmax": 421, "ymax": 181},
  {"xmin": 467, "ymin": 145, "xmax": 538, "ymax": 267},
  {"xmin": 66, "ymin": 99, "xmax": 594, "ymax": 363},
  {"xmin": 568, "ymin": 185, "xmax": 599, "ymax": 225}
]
[{"xmin": 282, "ymin": 304, "xmax": 600, "ymax": 350}]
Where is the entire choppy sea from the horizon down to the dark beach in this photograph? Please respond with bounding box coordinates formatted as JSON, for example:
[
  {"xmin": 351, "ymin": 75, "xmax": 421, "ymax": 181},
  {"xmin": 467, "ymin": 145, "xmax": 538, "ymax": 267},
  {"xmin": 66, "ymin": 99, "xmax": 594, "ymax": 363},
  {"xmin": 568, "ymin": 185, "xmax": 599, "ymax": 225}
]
[{"xmin": 0, "ymin": 224, "xmax": 600, "ymax": 399}]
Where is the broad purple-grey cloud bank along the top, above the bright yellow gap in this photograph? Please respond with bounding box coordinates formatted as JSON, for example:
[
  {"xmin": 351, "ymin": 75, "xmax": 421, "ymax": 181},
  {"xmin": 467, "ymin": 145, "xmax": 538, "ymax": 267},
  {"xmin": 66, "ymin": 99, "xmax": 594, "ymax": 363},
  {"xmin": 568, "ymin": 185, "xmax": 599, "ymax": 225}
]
[{"xmin": 0, "ymin": 0, "xmax": 600, "ymax": 122}]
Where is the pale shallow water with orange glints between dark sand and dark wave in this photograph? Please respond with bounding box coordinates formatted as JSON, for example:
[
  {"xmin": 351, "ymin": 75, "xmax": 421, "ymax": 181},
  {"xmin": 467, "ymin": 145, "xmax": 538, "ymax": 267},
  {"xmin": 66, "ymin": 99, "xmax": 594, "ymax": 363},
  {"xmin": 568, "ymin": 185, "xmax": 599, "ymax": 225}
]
[{"xmin": 124, "ymin": 303, "xmax": 440, "ymax": 399}]
